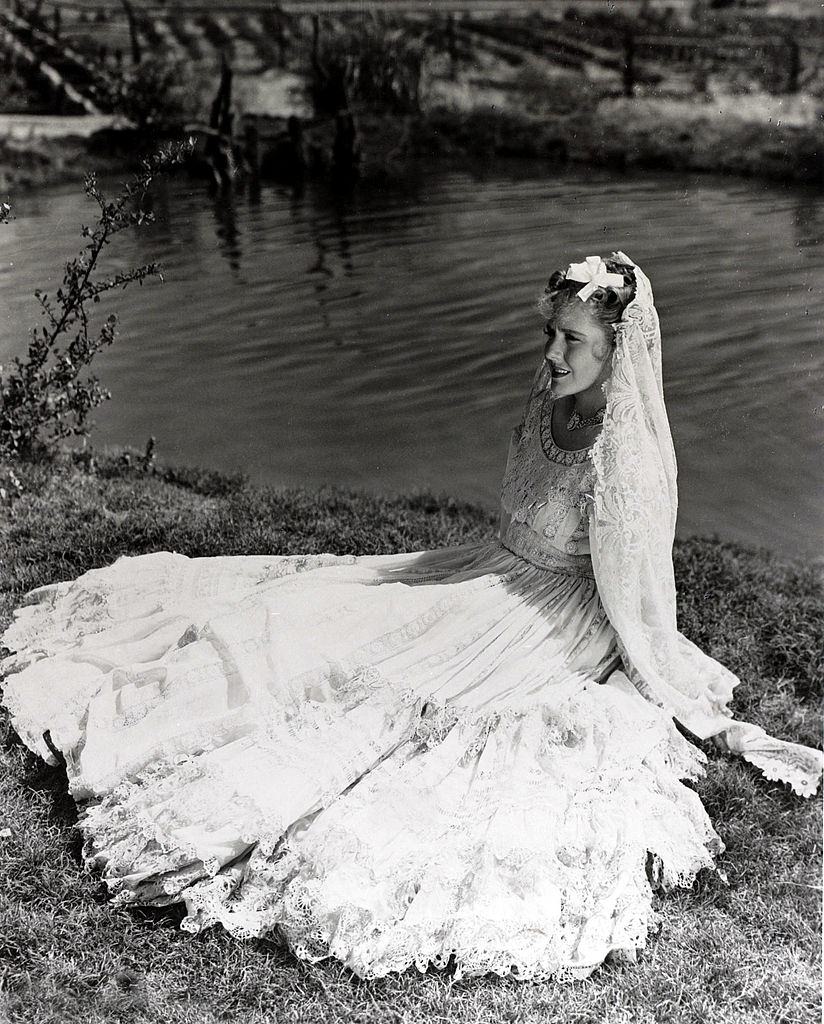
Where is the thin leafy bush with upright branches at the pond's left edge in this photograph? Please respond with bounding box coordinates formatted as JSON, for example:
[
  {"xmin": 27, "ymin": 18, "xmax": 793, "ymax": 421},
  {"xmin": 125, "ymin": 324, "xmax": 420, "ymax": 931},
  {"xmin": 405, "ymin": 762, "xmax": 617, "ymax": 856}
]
[{"xmin": 0, "ymin": 145, "xmax": 188, "ymax": 459}]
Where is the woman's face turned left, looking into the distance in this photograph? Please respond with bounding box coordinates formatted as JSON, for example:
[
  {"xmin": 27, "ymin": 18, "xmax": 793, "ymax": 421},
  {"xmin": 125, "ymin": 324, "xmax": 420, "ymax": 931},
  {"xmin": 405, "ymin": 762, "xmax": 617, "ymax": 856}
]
[{"xmin": 544, "ymin": 300, "xmax": 612, "ymax": 397}]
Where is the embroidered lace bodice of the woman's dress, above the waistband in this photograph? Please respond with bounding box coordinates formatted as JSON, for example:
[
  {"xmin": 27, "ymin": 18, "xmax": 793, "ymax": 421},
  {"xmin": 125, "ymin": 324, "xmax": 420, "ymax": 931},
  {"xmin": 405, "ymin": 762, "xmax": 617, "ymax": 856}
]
[{"xmin": 500, "ymin": 391, "xmax": 595, "ymax": 577}]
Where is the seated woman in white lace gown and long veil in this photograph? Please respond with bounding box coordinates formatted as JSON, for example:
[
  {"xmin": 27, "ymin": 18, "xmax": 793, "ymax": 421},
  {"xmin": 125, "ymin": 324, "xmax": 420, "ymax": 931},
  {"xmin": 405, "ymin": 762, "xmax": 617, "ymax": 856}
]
[{"xmin": 3, "ymin": 252, "xmax": 822, "ymax": 978}]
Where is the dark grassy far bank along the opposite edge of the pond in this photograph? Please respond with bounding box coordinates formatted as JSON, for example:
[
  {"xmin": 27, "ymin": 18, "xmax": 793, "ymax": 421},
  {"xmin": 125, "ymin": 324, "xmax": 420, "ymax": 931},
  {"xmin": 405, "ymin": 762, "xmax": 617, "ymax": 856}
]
[{"xmin": 0, "ymin": 90, "xmax": 824, "ymax": 196}]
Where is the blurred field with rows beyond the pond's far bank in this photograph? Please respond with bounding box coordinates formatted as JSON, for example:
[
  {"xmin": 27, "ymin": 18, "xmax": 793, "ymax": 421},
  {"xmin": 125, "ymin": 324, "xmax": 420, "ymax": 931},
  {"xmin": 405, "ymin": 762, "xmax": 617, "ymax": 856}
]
[{"xmin": 0, "ymin": 0, "xmax": 824, "ymax": 115}]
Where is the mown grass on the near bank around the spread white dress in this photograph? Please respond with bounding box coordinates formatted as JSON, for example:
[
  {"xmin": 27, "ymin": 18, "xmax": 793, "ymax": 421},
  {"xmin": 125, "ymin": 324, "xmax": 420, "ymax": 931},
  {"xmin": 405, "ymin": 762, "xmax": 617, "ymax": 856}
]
[{"xmin": 0, "ymin": 453, "xmax": 824, "ymax": 1024}]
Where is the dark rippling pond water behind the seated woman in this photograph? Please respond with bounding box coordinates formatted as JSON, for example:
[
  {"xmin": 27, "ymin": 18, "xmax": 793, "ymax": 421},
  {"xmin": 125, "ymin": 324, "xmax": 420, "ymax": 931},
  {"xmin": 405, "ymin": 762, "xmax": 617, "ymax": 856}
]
[{"xmin": 0, "ymin": 164, "xmax": 824, "ymax": 556}]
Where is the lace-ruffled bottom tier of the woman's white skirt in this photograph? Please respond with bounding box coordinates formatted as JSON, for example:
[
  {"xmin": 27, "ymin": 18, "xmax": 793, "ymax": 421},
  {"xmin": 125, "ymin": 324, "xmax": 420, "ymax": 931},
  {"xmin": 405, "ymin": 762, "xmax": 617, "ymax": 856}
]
[{"xmin": 80, "ymin": 673, "xmax": 723, "ymax": 980}]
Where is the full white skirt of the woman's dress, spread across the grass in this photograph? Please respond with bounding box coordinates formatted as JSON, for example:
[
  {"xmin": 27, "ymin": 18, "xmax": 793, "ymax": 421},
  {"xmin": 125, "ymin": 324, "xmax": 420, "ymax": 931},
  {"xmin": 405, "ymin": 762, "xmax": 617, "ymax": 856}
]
[{"xmin": 2, "ymin": 543, "xmax": 794, "ymax": 979}]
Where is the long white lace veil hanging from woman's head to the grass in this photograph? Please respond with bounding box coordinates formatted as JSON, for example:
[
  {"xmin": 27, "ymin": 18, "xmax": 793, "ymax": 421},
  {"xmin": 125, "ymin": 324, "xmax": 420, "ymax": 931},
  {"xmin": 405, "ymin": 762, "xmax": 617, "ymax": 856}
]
[{"xmin": 590, "ymin": 252, "xmax": 824, "ymax": 796}]
